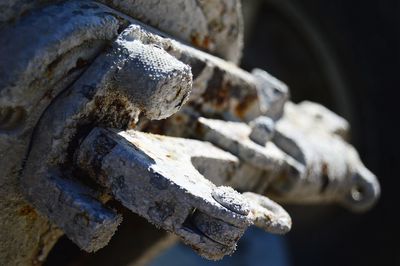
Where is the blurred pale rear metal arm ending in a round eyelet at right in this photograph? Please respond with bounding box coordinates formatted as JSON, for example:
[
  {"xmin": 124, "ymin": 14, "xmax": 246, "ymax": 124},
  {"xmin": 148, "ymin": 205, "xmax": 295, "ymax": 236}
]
[{"xmin": 185, "ymin": 102, "xmax": 380, "ymax": 211}]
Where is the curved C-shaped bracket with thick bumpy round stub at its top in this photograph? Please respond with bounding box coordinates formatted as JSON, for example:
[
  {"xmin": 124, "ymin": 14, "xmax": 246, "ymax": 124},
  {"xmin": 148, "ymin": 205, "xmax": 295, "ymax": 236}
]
[{"xmin": 21, "ymin": 24, "xmax": 191, "ymax": 254}]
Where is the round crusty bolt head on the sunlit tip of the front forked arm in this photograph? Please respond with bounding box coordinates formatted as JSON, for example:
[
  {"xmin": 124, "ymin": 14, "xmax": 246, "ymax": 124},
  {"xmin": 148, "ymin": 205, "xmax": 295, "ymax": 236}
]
[{"xmin": 211, "ymin": 186, "xmax": 250, "ymax": 215}]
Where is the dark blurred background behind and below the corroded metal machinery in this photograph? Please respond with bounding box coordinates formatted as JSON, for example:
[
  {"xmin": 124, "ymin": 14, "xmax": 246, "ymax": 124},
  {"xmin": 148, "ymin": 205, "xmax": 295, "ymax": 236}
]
[{"xmin": 46, "ymin": 0, "xmax": 400, "ymax": 266}]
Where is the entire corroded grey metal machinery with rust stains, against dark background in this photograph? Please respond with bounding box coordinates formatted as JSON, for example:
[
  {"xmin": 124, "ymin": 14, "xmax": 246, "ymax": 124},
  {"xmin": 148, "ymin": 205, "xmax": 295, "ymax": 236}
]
[{"xmin": 0, "ymin": 0, "xmax": 380, "ymax": 265}]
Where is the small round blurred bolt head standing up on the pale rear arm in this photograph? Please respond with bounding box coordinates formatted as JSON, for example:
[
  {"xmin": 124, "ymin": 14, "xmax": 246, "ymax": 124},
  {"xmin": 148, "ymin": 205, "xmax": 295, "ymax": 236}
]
[{"xmin": 249, "ymin": 116, "xmax": 275, "ymax": 146}]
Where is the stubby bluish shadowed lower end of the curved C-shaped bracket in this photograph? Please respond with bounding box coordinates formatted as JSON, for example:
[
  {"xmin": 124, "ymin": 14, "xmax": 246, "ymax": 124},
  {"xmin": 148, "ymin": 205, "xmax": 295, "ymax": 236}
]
[{"xmin": 25, "ymin": 171, "xmax": 122, "ymax": 252}]
